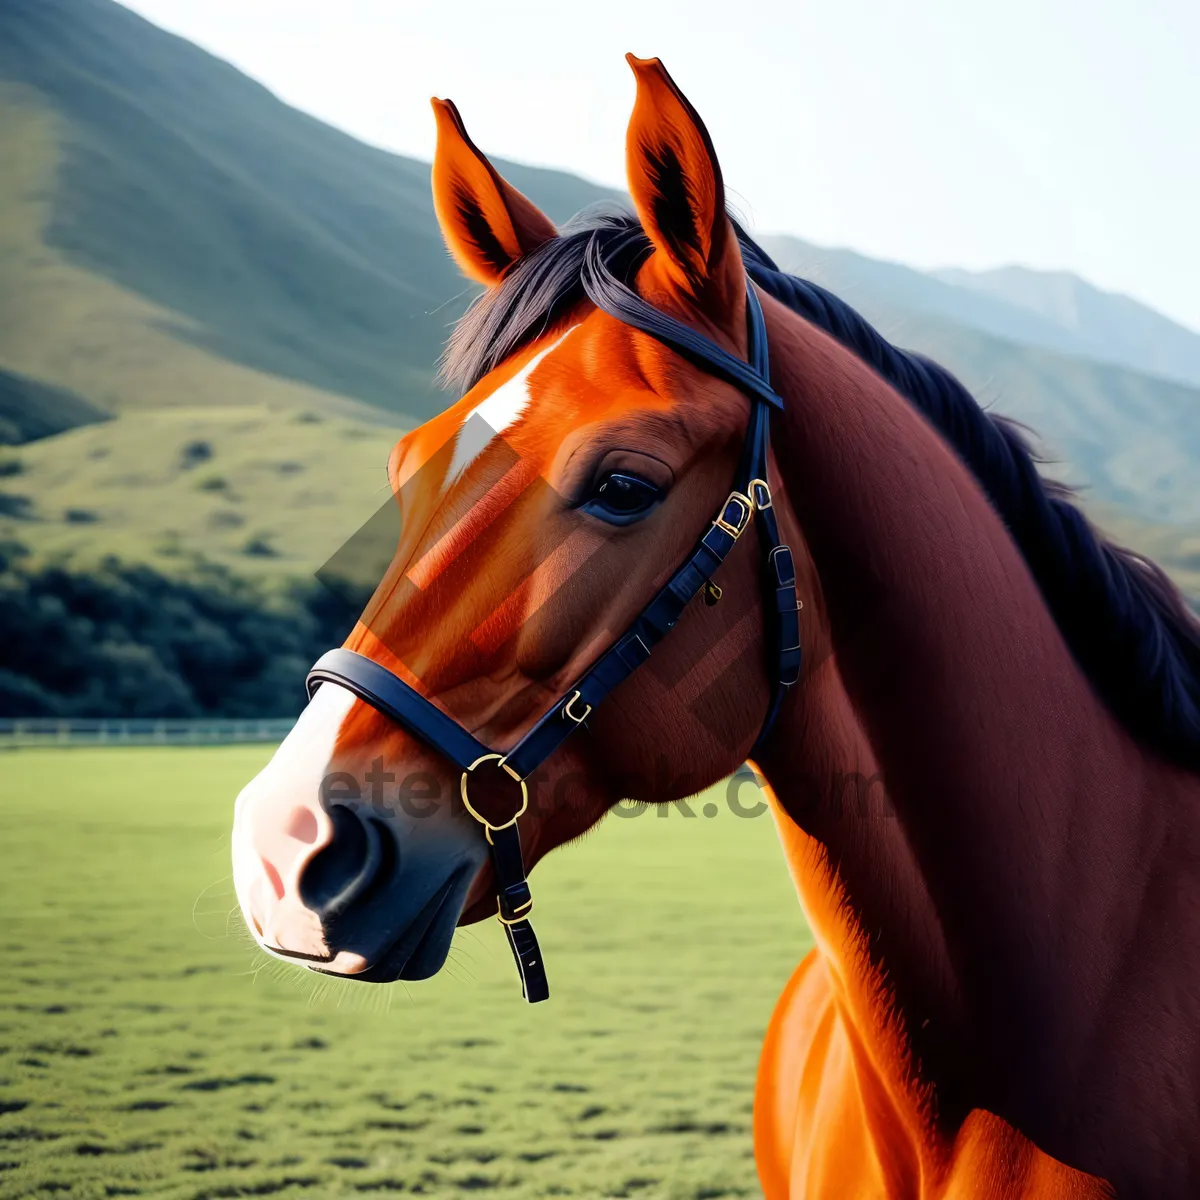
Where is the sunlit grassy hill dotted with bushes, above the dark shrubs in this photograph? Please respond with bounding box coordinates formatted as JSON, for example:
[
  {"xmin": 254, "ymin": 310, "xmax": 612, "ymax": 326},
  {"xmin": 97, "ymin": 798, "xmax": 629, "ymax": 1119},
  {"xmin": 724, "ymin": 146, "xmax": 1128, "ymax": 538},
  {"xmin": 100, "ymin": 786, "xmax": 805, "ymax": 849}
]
[{"xmin": 0, "ymin": 407, "xmax": 400, "ymax": 580}]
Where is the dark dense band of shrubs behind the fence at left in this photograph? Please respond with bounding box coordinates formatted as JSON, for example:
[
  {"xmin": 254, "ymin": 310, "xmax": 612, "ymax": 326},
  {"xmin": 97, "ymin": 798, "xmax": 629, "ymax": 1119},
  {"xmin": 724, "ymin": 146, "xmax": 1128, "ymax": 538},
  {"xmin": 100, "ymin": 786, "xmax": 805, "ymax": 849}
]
[{"xmin": 0, "ymin": 544, "xmax": 358, "ymax": 718}]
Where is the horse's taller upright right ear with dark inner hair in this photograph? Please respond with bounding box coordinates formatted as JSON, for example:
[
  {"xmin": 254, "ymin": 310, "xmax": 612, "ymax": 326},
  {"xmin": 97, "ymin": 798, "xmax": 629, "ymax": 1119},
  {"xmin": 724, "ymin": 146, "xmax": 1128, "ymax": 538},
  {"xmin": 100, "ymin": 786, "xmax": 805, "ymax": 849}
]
[{"xmin": 625, "ymin": 54, "xmax": 739, "ymax": 295}]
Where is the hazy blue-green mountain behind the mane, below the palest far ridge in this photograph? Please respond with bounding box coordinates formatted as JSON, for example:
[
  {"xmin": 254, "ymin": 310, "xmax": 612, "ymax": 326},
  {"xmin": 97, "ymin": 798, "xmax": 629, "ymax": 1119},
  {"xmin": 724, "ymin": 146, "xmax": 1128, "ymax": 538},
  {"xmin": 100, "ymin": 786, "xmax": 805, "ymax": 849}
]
[{"xmin": 762, "ymin": 235, "xmax": 1200, "ymax": 524}]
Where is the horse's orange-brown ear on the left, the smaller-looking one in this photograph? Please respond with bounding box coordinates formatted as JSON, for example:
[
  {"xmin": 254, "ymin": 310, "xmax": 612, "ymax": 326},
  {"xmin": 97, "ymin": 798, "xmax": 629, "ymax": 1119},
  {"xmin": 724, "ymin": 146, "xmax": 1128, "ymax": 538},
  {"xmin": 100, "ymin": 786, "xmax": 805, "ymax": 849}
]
[{"xmin": 432, "ymin": 97, "xmax": 558, "ymax": 287}]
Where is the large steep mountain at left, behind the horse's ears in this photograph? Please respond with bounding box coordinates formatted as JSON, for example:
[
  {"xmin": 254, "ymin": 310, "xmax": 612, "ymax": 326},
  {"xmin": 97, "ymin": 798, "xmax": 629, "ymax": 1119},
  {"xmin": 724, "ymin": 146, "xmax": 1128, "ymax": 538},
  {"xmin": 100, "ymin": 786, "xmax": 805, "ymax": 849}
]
[{"xmin": 0, "ymin": 0, "xmax": 612, "ymax": 427}]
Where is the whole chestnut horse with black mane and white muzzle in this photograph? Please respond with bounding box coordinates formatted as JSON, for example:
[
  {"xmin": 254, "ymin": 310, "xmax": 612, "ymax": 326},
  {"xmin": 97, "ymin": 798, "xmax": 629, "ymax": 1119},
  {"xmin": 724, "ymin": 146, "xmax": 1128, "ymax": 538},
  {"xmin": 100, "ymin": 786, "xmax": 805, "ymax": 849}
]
[{"xmin": 233, "ymin": 55, "xmax": 1200, "ymax": 1200}]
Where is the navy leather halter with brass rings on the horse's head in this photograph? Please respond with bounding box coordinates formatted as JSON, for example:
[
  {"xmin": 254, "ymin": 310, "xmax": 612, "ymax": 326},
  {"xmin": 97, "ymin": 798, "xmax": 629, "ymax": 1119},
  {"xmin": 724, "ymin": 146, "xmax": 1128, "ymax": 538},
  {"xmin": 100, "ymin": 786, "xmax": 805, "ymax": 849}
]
[{"xmin": 307, "ymin": 259, "xmax": 800, "ymax": 1003}]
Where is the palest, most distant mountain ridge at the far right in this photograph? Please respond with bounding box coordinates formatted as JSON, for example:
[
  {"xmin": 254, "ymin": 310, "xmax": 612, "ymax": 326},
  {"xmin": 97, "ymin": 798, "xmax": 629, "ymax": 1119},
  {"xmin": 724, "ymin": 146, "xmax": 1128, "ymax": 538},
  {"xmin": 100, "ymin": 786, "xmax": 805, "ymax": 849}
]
[{"xmin": 934, "ymin": 266, "xmax": 1200, "ymax": 386}]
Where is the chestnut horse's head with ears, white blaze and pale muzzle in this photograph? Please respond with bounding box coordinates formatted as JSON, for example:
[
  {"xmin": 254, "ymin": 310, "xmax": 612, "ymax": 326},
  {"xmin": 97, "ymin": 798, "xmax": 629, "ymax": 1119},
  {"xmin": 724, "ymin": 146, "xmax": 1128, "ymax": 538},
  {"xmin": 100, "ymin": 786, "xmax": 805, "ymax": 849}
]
[{"xmin": 226, "ymin": 56, "xmax": 806, "ymax": 982}]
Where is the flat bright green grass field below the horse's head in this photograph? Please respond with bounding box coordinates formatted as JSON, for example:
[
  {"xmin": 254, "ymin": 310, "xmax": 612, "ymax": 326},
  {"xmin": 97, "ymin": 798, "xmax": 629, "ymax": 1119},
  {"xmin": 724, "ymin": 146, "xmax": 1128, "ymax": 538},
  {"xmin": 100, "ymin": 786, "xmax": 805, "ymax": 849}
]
[{"xmin": 0, "ymin": 748, "xmax": 809, "ymax": 1200}]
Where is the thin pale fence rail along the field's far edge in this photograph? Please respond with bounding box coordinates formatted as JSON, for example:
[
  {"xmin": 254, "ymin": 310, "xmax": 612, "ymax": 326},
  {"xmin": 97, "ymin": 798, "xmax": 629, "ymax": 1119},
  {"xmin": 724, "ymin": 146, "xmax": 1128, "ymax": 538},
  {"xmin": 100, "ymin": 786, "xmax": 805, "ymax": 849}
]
[{"xmin": 0, "ymin": 716, "xmax": 295, "ymax": 750}]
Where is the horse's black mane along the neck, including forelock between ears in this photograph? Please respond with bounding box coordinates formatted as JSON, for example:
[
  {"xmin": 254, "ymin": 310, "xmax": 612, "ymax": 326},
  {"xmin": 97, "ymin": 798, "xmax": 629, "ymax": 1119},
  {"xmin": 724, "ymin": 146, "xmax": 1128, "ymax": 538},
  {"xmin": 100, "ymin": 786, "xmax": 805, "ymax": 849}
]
[{"xmin": 442, "ymin": 205, "xmax": 1200, "ymax": 770}]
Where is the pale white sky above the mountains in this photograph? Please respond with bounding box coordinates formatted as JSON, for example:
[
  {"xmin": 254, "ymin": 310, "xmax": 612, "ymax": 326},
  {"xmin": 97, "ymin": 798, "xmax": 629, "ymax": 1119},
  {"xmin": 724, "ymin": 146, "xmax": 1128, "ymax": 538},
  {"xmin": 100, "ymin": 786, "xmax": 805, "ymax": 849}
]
[{"xmin": 126, "ymin": 0, "xmax": 1200, "ymax": 330}]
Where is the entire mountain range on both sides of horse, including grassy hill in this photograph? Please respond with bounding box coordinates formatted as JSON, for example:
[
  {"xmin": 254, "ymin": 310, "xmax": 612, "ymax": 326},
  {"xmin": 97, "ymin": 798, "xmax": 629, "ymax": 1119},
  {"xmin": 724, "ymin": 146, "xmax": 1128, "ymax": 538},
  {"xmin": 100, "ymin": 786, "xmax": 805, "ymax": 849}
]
[{"xmin": 0, "ymin": 0, "xmax": 1200, "ymax": 574}]
